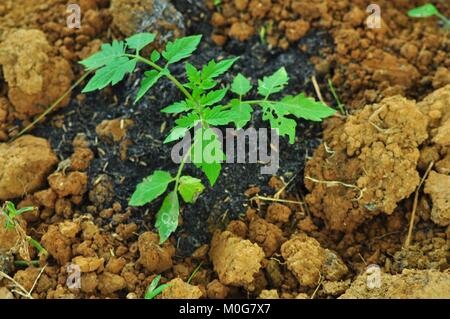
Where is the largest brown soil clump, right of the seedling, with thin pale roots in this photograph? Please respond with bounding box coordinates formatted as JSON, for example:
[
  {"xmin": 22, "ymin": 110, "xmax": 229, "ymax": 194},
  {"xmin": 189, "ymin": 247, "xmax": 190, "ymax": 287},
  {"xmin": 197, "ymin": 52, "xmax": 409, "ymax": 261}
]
[{"xmin": 305, "ymin": 96, "xmax": 428, "ymax": 232}]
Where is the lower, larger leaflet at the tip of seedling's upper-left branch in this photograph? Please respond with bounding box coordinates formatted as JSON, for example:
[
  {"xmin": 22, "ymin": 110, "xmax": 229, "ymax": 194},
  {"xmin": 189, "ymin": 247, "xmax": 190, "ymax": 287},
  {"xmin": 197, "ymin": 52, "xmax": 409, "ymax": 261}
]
[{"xmin": 82, "ymin": 57, "xmax": 137, "ymax": 93}]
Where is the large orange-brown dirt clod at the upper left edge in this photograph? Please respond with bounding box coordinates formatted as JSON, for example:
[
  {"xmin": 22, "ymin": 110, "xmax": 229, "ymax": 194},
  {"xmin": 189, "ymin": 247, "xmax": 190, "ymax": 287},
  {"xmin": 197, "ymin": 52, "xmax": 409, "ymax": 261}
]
[{"xmin": 0, "ymin": 29, "xmax": 73, "ymax": 119}]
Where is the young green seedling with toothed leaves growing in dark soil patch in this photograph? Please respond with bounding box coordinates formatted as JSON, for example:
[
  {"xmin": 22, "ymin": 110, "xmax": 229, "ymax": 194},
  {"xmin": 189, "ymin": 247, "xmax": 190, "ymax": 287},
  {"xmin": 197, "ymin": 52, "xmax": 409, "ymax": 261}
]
[{"xmin": 80, "ymin": 33, "xmax": 335, "ymax": 243}]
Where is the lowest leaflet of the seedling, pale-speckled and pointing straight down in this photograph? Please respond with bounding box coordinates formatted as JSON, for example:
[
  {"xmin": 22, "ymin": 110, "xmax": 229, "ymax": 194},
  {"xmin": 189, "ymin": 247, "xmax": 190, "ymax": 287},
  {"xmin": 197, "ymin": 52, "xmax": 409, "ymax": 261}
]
[{"xmin": 155, "ymin": 191, "xmax": 180, "ymax": 244}]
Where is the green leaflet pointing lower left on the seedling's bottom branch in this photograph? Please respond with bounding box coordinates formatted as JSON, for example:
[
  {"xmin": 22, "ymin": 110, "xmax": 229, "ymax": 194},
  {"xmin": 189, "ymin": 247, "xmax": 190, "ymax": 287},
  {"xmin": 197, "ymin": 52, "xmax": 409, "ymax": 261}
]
[{"xmin": 129, "ymin": 171, "xmax": 173, "ymax": 206}]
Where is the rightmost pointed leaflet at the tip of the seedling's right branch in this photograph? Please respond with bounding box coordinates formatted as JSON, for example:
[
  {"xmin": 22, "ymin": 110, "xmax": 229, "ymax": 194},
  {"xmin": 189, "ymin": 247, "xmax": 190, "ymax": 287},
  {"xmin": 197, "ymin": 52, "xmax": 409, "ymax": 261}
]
[{"xmin": 273, "ymin": 93, "xmax": 336, "ymax": 122}]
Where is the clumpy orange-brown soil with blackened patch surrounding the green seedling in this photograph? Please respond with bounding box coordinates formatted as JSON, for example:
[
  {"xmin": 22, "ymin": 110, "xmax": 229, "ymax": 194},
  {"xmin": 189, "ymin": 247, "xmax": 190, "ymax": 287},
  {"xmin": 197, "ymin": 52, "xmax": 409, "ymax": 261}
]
[{"xmin": 0, "ymin": 0, "xmax": 450, "ymax": 299}]
